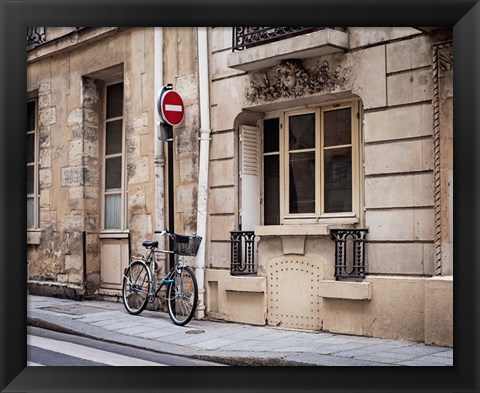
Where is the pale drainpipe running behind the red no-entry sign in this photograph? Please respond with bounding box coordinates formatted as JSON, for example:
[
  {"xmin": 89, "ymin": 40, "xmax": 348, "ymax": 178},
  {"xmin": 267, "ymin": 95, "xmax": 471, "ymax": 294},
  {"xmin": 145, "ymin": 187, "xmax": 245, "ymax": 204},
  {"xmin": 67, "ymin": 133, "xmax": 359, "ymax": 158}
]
[{"xmin": 156, "ymin": 27, "xmax": 169, "ymax": 253}]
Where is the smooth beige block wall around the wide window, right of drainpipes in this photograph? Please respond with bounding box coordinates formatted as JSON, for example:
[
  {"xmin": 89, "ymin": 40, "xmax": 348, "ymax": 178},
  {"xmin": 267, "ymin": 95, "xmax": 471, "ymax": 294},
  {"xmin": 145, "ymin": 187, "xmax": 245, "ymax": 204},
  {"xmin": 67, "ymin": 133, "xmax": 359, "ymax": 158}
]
[{"xmin": 207, "ymin": 27, "xmax": 453, "ymax": 345}]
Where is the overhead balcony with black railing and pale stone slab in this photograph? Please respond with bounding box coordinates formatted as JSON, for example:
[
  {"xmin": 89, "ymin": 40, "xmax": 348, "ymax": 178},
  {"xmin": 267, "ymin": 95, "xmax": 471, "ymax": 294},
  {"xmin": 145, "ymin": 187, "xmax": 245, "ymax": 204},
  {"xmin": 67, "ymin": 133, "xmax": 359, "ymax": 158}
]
[{"xmin": 227, "ymin": 27, "xmax": 349, "ymax": 71}]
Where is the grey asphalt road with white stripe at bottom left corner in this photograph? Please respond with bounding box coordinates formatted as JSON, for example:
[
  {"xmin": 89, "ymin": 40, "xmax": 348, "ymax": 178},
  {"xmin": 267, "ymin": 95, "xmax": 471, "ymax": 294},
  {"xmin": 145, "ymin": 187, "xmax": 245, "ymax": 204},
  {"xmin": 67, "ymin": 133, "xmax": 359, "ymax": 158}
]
[{"xmin": 27, "ymin": 326, "xmax": 223, "ymax": 366}]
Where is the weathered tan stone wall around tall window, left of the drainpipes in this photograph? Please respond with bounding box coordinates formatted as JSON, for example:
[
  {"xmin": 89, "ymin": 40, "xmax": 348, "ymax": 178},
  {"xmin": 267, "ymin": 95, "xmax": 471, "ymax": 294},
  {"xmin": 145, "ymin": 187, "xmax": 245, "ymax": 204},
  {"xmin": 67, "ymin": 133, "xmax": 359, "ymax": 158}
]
[{"xmin": 27, "ymin": 28, "xmax": 155, "ymax": 293}]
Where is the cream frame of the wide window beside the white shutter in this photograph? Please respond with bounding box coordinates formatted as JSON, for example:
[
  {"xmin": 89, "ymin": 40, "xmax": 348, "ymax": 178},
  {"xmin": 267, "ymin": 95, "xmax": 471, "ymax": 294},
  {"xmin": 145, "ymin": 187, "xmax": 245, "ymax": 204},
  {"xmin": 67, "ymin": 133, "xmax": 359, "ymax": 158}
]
[{"xmin": 259, "ymin": 98, "xmax": 363, "ymax": 226}]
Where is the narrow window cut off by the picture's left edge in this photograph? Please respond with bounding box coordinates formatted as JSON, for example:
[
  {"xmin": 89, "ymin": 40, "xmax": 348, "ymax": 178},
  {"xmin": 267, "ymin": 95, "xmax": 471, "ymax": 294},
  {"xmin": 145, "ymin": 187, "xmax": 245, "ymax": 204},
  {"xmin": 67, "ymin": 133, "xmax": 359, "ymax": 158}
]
[{"xmin": 26, "ymin": 97, "xmax": 40, "ymax": 232}]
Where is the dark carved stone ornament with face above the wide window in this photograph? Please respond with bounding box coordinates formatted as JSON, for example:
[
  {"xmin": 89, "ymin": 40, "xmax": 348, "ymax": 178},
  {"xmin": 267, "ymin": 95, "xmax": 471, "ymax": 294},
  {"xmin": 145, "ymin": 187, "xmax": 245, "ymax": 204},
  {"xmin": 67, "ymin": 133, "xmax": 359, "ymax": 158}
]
[{"xmin": 246, "ymin": 60, "xmax": 343, "ymax": 102}]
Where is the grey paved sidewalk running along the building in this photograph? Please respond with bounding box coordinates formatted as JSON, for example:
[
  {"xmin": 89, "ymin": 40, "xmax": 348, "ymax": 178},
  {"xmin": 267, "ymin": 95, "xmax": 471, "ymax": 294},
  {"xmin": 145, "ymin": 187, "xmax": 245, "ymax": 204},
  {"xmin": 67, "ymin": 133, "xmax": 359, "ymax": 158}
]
[{"xmin": 27, "ymin": 295, "xmax": 453, "ymax": 366}]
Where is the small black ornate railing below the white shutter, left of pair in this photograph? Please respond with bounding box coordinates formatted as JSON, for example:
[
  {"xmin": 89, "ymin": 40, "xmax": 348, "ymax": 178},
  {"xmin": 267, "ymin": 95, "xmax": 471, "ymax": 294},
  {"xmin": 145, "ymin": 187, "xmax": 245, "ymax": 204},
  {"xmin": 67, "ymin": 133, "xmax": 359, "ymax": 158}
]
[{"xmin": 230, "ymin": 231, "xmax": 257, "ymax": 276}]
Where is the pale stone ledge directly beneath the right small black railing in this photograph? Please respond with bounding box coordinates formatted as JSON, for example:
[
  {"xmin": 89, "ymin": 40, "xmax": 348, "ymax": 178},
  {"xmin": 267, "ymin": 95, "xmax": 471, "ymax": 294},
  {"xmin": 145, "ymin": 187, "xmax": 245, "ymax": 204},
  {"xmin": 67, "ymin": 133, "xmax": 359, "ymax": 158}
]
[{"xmin": 318, "ymin": 280, "xmax": 372, "ymax": 300}]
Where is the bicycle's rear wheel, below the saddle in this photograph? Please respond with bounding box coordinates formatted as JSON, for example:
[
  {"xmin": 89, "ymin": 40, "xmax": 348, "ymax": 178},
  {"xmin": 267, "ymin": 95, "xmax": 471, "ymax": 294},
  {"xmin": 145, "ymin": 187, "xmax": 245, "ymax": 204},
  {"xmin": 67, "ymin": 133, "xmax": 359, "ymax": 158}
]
[{"xmin": 122, "ymin": 261, "xmax": 152, "ymax": 315}]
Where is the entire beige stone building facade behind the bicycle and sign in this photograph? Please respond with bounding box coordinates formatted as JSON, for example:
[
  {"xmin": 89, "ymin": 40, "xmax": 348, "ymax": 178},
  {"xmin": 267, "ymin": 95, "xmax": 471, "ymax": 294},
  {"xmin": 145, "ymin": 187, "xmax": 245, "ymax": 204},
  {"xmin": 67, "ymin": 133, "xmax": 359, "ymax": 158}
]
[{"xmin": 27, "ymin": 27, "xmax": 453, "ymax": 345}]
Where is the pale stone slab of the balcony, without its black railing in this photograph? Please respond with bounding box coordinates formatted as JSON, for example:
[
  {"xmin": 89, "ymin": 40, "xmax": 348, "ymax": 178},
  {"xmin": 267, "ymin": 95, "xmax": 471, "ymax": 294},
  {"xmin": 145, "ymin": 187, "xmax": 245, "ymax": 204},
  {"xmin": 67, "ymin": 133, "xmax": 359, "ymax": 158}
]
[{"xmin": 227, "ymin": 29, "xmax": 349, "ymax": 71}]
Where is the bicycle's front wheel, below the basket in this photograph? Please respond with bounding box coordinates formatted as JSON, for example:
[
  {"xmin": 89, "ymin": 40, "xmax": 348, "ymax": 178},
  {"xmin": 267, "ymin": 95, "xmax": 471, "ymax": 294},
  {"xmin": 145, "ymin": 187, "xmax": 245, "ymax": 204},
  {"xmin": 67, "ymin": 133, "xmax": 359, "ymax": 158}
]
[{"xmin": 167, "ymin": 266, "xmax": 198, "ymax": 326}]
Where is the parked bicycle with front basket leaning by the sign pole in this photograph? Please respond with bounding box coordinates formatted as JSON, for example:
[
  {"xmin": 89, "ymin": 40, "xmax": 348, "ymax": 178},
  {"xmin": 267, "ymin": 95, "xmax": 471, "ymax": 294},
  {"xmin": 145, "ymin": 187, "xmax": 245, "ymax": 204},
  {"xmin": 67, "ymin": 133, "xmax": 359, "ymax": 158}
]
[{"xmin": 122, "ymin": 230, "xmax": 202, "ymax": 326}]
